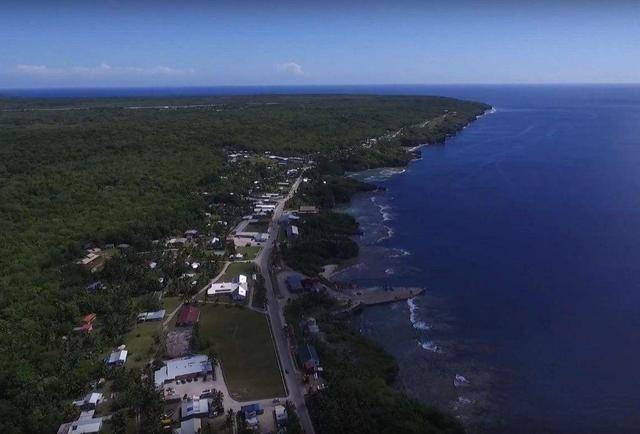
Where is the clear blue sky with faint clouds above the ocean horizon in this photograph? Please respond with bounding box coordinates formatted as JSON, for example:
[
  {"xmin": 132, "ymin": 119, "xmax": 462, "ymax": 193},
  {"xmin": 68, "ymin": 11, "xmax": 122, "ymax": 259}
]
[{"xmin": 0, "ymin": 0, "xmax": 640, "ymax": 88}]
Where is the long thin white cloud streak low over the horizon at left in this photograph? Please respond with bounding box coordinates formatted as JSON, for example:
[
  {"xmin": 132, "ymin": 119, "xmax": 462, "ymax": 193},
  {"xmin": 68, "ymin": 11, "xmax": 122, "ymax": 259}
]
[{"xmin": 15, "ymin": 63, "xmax": 195, "ymax": 78}]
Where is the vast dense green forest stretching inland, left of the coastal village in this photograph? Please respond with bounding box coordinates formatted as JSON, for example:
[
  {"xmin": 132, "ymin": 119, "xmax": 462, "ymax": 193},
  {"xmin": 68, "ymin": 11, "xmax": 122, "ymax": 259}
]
[{"xmin": 0, "ymin": 96, "xmax": 488, "ymax": 433}]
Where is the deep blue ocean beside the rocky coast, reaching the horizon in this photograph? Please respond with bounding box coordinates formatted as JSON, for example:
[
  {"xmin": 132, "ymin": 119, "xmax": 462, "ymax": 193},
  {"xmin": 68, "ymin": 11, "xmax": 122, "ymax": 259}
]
[{"xmin": 10, "ymin": 85, "xmax": 640, "ymax": 433}]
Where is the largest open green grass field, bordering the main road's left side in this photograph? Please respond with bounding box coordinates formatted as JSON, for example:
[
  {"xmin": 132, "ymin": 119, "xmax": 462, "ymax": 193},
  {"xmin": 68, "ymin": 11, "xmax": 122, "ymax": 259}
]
[{"xmin": 200, "ymin": 305, "xmax": 285, "ymax": 401}]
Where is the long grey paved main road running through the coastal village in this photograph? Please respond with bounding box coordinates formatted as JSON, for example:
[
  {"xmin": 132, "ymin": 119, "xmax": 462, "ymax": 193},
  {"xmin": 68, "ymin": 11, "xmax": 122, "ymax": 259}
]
[{"xmin": 254, "ymin": 178, "xmax": 315, "ymax": 434}]
